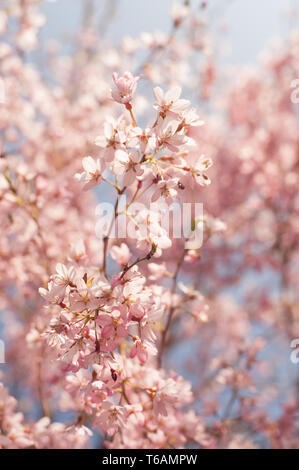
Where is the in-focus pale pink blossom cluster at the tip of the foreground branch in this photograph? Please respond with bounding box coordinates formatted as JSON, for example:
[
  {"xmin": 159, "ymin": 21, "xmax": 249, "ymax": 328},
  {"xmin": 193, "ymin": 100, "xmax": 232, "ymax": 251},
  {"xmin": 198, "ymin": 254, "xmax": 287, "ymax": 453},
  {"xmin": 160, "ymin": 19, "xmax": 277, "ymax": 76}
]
[{"xmin": 76, "ymin": 79, "xmax": 212, "ymax": 198}]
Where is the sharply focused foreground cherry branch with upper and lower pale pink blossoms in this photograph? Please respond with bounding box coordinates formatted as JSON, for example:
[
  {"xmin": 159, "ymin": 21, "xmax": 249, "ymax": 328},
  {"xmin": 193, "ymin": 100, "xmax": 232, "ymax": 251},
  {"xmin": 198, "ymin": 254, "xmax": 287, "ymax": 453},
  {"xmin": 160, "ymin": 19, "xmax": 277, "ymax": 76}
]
[{"xmin": 40, "ymin": 72, "xmax": 212, "ymax": 446}]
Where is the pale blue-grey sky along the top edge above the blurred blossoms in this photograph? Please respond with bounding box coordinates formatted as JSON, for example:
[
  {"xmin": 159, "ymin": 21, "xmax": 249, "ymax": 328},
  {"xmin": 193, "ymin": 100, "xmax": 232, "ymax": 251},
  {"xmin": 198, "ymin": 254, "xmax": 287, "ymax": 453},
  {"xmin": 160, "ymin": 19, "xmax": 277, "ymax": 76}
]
[{"xmin": 42, "ymin": 0, "xmax": 299, "ymax": 64}]
